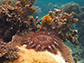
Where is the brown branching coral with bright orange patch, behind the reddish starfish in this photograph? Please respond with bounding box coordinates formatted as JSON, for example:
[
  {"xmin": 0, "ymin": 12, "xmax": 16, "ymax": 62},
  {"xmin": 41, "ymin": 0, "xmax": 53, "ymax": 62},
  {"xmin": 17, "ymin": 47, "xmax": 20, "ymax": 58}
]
[{"xmin": 37, "ymin": 9, "xmax": 78, "ymax": 44}]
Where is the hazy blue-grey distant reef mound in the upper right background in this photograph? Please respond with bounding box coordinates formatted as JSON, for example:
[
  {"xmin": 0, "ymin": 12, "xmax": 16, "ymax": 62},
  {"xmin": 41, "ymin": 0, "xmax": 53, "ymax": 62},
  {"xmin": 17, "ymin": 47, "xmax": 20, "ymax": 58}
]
[{"xmin": 61, "ymin": 3, "xmax": 84, "ymax": 45}]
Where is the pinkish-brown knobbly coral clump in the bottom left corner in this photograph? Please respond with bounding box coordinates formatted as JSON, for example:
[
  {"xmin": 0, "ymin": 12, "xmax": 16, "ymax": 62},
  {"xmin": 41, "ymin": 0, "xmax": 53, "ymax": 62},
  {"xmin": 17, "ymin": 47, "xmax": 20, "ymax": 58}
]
[{"xmin": 0, "ymin": 41, "xmax": 19, "ymax": 62}]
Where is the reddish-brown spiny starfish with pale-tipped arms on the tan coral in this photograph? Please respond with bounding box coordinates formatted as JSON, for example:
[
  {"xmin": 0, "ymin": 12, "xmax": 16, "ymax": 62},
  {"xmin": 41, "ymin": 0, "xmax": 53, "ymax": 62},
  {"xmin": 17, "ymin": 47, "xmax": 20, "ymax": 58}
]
[{"xmin": 22, "ymin": 31, "xmax": 61, "ymax": 53}]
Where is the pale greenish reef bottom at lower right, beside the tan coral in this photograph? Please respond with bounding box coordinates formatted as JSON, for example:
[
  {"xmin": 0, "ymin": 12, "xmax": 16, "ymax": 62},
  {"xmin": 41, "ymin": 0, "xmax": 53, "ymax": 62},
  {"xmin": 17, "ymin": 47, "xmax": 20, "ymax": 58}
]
[{"xmin": 64, "ymin": 41, "xmax": 83, "ymax": 63}]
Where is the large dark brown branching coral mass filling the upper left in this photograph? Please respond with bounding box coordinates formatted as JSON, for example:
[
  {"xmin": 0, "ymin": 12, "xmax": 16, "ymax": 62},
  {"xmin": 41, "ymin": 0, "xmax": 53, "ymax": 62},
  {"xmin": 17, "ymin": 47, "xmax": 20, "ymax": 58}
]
[{"xmin": 0, "ymin": 0, "xmax": 36, "ymax": 42}]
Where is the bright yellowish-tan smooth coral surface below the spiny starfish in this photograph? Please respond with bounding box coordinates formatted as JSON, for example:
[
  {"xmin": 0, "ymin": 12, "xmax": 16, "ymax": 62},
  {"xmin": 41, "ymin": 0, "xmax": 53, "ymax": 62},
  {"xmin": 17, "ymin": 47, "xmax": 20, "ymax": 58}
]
[{"xmin": 9, "ymin": 46, "xmax": 65, "ymax": 63}]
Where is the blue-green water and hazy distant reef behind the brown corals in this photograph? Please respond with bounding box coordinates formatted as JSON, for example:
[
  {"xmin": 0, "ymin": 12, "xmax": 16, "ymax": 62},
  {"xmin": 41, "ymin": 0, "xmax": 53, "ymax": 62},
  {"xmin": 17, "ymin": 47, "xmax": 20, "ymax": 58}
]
[{"xmin": 36, "ymin": 0, "xmax": 84, "ymax": 63}]
